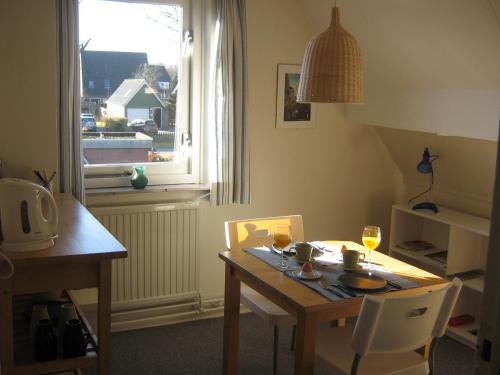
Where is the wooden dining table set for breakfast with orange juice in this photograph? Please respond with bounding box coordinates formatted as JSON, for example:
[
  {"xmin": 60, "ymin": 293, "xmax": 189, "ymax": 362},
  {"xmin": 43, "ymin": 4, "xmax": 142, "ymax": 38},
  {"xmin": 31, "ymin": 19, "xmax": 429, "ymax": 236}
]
[{"xmin": 219, "ymin": 240, "xmax": 448, "ymax": 375}]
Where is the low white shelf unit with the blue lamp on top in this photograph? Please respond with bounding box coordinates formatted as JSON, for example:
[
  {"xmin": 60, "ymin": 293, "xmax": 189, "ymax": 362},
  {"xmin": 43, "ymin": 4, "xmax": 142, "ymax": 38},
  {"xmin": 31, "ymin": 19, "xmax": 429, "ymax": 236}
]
[{"xmin": 389, "ymin": 204, "xmax": 490, "ymax": 347}]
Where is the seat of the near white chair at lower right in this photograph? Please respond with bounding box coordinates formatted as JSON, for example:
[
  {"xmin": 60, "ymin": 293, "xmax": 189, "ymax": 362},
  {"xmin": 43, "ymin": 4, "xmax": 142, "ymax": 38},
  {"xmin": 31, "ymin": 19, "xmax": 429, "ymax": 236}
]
[{"xmin": 316, "ymin": 325, "xmax": 429, "ymax": 375}]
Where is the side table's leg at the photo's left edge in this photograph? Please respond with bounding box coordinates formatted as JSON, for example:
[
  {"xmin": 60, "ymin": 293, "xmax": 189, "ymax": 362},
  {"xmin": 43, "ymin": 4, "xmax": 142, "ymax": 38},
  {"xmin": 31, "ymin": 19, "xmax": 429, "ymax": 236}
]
[{"xmin": 0, "ymin": 279, "xmax": 14, "ymax": 375}]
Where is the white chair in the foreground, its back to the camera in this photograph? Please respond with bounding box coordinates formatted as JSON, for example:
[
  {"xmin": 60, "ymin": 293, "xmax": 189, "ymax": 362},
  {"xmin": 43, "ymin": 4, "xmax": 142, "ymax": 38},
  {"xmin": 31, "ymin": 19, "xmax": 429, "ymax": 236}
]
[{"xmin": 316, "ymin": 279, "xmax": 462, "ymax": 375}]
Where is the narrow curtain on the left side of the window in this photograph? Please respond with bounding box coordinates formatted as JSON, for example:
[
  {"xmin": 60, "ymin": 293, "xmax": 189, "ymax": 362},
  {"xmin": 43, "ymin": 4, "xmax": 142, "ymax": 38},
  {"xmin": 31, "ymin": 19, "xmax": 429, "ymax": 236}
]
[{"xmin": 57, "ymin": 0, "xmax": 84, "ymax": 202}]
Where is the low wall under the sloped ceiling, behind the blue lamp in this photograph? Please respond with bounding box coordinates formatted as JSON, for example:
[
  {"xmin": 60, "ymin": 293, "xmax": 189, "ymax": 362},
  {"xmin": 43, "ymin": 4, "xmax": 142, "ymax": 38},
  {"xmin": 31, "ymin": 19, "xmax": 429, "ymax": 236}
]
[{"xmin": 377, "ymin": 127, "xmax": 497, "ymax": 217}]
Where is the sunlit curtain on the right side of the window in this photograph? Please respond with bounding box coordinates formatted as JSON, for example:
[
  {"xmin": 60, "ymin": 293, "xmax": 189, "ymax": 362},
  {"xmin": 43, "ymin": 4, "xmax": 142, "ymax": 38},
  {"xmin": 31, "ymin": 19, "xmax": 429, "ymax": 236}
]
[{"xmin": 208, "ymin": 0, "xmax": 250, "ymax": 205}]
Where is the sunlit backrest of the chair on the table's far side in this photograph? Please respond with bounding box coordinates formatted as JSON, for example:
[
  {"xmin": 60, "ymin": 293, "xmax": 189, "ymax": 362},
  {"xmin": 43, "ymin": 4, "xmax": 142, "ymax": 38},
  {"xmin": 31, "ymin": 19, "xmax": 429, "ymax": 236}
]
[{"xmin": 225, "ymin": 215, "xmax": 304, "ymax": 250}]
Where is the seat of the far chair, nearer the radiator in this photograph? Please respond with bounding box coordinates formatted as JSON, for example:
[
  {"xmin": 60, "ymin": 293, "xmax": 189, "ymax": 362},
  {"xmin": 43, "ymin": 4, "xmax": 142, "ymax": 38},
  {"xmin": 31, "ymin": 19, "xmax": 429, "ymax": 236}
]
[{"xmin": 241, "ymin": 284, "xmax": 295, "ymax": 325}]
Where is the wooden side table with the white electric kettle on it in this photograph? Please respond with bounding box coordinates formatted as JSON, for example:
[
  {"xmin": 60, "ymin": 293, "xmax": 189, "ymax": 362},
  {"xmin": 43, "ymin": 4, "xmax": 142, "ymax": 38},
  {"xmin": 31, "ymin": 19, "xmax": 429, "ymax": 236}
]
[{"xmin": 0, "ymin": 194, "xmax": 127, "ymax": 375}]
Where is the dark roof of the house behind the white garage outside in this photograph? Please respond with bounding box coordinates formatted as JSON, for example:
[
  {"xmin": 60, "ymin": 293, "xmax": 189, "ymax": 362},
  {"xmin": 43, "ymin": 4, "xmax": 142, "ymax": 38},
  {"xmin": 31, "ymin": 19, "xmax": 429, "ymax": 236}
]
[{"xmin": 81, "ymin": 51, "xmax": 148, "ymax": 98}]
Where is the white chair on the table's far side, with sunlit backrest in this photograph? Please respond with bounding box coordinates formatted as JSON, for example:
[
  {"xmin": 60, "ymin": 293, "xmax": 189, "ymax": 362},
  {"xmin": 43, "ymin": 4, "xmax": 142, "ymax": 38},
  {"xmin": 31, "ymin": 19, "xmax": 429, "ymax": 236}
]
[{"xmin": 225, "ymin": 215, "xmax": 304, "ymax": 374}]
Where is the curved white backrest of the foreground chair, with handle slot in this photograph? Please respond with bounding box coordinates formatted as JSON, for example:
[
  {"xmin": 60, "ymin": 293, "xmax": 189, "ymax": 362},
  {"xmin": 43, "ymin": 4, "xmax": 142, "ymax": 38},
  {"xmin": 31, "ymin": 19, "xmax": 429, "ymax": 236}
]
[{"xmin": 352, "ymin": 278, "xmax": 462, "ymax": 356}]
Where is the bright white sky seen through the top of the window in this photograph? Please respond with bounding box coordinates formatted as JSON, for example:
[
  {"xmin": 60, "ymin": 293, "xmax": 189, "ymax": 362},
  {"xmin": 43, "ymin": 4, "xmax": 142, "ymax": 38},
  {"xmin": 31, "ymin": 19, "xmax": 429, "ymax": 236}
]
[{"xmin": 79, "ymin": 0, "xmax": 182, "ymax": 66}]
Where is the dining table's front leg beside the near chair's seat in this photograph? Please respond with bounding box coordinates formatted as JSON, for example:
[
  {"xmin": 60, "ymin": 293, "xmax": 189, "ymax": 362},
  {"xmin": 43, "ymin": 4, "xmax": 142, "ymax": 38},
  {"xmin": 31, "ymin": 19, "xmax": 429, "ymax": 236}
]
[{"xmin": 295, "ymin": 312, "xmax": 318, "ymax": 375}]
